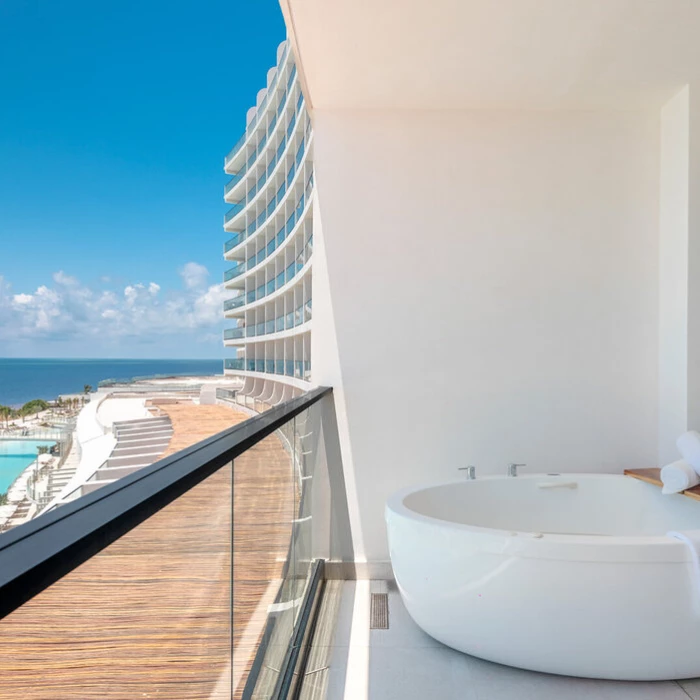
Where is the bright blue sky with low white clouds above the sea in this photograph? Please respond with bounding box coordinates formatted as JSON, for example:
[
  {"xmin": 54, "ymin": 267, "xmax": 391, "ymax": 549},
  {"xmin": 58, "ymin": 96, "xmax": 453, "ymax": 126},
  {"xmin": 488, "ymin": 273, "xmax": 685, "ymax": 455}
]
[{"xmin": 0, "ymin": 0, "xmax": 285, "ymax": 357}]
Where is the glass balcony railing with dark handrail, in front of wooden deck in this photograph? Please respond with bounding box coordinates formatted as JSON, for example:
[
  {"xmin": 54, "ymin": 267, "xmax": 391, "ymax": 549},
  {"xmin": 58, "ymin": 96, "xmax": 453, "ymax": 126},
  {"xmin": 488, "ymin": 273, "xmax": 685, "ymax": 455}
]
[{"xmin": 0, "ymin": 388, "xmax": 340, "ymax": 700}]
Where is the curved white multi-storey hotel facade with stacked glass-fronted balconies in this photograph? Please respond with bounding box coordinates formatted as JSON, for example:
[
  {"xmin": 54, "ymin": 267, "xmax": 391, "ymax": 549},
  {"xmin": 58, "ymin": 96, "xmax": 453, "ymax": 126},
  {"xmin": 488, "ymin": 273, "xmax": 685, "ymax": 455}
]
[{"xmin": 224, "ymin": 41, "xmax": 313, "ymax": 410}]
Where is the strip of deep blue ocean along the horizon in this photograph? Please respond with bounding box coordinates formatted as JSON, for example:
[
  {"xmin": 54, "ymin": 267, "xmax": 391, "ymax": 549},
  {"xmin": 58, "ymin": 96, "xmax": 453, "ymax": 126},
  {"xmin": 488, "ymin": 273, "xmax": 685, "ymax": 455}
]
[{"xmin": 0, "ymin": 358, "xmax": 223, "ymax": 407}]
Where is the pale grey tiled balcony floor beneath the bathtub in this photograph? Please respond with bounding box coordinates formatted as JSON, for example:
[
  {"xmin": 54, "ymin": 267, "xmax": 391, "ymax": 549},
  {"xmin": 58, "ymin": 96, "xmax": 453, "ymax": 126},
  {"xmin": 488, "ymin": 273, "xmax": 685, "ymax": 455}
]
[{"xmin": 326, "ymin": 581, "xmax": 700, "ymax": 700}]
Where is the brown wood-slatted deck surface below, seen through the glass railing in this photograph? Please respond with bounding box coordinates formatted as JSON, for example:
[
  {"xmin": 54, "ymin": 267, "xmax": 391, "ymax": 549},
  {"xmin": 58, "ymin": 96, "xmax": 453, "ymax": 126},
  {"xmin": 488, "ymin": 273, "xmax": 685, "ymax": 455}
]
[{"xmin": 0, "ymin": 406, "xmax": 294, "ymax": 700}]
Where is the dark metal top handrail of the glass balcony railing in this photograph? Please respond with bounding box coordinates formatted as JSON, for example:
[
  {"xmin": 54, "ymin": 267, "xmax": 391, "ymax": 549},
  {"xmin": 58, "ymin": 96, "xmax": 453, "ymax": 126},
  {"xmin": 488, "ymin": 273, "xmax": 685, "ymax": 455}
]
[{"xmin": 0, "ymin": 387, "xmax": 332, "ymax": 619}]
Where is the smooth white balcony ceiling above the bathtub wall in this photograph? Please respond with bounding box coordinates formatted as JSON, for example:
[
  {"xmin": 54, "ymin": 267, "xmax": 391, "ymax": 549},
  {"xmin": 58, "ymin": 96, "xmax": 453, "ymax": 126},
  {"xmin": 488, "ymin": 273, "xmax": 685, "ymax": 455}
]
[{"xmin": 281, "ymin": 0, "xmax": 700, "ymax": 109}]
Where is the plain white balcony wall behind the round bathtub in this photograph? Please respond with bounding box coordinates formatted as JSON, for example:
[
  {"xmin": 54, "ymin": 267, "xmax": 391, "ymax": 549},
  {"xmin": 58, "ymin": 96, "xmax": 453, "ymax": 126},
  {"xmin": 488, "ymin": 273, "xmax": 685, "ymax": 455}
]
[{"xmin": 311, "ymin": 109, "xmax": 660, "ymax": 561}]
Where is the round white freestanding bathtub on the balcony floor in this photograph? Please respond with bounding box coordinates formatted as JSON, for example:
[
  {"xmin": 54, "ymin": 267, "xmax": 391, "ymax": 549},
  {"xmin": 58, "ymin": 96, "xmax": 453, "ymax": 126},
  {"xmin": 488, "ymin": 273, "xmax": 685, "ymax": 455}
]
[{"xmin": 386, "ymin": 474, "xmax": 700, "ymax": 680}]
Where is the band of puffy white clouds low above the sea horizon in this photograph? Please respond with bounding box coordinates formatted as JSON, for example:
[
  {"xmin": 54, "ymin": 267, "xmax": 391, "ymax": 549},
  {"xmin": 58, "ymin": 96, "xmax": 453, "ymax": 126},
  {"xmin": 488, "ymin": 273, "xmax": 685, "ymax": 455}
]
[{"xmin": 0, "ymin": 263, "xmax": 229, "ymax": 342}]
